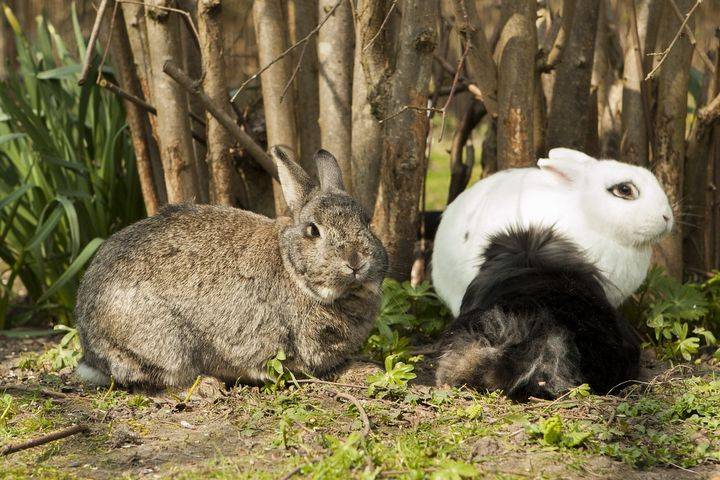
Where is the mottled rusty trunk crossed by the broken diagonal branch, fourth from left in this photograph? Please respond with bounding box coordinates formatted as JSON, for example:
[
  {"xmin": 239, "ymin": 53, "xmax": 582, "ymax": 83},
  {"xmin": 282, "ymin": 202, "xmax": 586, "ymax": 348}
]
[{"xmin": 198, "ymin": 0, "xmax": 236, "ymax": 208}]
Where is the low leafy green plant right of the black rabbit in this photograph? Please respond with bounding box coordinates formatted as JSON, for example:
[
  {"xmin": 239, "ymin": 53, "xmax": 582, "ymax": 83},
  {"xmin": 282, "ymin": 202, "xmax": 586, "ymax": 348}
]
[{"xmin": 633, "ymin": 267, "xmax": 720, "ymax": 361}]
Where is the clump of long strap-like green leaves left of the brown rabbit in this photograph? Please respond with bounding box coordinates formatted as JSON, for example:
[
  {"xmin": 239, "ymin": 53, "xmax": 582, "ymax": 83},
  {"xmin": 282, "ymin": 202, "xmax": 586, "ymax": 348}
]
[{"xmin": 0, "ymin": 4, "xmax": 144, "ymax": 329}]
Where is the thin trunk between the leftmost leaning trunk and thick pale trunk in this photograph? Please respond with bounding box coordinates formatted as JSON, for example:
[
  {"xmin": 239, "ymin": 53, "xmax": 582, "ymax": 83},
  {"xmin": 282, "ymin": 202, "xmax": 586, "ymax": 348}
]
[{"xmin": 120, "ymin": 3, "xmax": 167, "ymax": 205}]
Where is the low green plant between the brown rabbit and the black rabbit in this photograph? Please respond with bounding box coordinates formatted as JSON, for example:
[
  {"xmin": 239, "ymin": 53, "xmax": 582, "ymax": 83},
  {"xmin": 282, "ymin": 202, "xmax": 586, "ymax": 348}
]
[{"xmin": 365, "ymin": 278, "xmax": 451, "ymax": 360}]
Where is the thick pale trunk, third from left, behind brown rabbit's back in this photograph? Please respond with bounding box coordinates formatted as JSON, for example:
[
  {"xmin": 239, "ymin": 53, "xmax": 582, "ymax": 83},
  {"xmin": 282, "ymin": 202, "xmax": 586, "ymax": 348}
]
[{"xmin": 146, "ymin": 0, "xmax": 199, "ymax": 203}]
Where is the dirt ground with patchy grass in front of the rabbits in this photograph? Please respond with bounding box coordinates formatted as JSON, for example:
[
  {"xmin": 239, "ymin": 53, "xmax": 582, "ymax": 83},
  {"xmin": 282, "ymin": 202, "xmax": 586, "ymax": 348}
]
[{"xmin": 0, "ymin": 336, "xmax": 720, "ymax": 480}]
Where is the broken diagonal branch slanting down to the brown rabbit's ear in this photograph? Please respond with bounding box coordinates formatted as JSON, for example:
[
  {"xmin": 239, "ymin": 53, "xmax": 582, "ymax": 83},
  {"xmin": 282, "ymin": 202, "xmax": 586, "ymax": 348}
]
[{"xmin": 163, "ymin": 60, "xmax": 278, "ymax": 179}]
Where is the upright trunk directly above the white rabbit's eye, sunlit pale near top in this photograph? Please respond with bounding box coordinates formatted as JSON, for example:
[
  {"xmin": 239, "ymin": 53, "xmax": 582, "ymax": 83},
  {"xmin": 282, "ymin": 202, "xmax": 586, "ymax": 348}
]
[{"xmin": 620, "ymin": 0, "xmax": 660, "ymax": 166}]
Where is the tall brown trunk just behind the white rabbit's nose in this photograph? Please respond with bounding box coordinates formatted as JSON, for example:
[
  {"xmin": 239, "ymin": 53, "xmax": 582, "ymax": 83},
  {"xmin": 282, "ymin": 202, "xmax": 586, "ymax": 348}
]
[{"xmin": 654, "ymin": 0, "xmax": 695, "ymax": 278}]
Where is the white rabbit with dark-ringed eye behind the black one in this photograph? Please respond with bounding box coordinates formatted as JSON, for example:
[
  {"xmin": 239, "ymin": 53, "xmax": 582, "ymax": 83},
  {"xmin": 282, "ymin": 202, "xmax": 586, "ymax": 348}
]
[{"xmin": 431, "ymin": 148, "xmax": 673, "ymax": 316}]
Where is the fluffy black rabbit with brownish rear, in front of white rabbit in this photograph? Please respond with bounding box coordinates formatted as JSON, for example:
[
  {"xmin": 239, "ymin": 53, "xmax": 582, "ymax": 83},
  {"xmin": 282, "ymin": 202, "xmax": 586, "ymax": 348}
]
[{"xmin": 436, "ymin": 226, "xmax": 640, "ymax": 400}]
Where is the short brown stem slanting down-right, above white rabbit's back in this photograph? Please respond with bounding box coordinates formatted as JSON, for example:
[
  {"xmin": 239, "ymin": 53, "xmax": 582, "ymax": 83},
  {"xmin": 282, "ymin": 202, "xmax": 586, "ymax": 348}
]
[{"xmin": 453, "ymin": 0, "xmax": 498, "ymax": 116}]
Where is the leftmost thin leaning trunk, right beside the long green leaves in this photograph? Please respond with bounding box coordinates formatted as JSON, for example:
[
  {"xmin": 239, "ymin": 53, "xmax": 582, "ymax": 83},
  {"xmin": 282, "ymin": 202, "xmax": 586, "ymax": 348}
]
[{"xmin": 110, "ymin": 5, "xmax": 160, "ymax": 216}]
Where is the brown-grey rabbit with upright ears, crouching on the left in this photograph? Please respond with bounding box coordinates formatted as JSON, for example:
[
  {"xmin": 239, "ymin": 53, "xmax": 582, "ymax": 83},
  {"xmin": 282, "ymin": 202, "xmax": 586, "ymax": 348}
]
[{"xmin": 76, "ymin": 147, "xmax": 388, "ymax": 390}]
